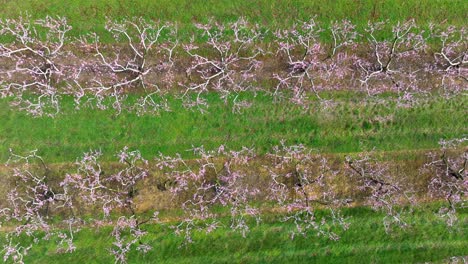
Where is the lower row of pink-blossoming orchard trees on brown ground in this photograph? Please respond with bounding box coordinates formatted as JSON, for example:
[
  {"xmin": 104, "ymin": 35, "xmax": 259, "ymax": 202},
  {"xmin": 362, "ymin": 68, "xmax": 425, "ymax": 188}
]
[{"xmin": 0, "ymin": 138, "xmax": 468, "ymax": 263}]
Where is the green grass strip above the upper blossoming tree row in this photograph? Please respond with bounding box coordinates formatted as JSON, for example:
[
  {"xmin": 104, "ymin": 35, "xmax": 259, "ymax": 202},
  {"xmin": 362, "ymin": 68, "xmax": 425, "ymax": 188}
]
[{"xmin": 0, "ymin": 0, "xmax": 468, "ymax": 41}]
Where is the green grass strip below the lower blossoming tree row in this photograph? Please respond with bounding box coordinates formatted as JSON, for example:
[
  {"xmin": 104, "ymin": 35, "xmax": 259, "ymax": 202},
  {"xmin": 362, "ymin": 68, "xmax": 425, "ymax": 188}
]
[{"xmin": 9, "ymin": 208, "xmax": 468, "ymax": 263}]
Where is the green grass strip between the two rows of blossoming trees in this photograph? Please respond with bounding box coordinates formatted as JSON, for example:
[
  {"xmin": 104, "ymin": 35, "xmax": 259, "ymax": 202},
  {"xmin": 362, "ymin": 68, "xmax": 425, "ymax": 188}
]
[{"xmin": 0, "ymin": 94, "xmax": 468, "ymax": 162}]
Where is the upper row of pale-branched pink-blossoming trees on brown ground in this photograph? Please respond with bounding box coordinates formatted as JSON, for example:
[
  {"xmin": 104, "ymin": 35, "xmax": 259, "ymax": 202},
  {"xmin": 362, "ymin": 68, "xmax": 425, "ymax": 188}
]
[{"xmin": 0, "ymin": 17, "xmax": 468, "ymax": 116}]
